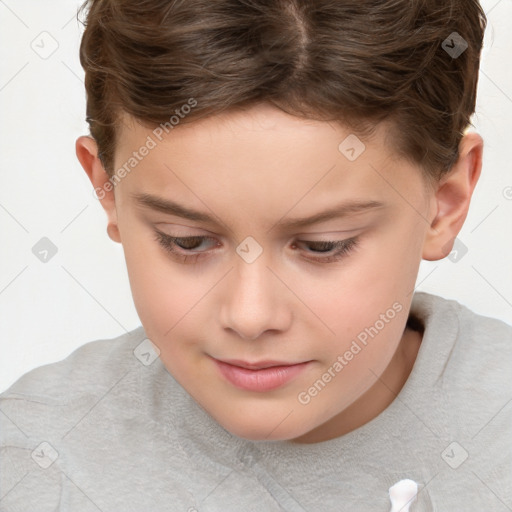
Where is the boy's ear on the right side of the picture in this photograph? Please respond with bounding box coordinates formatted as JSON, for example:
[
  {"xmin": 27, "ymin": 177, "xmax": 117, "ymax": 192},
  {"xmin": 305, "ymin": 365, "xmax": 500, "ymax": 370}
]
[{"xmin": 423, "ymin": 133, "xmax": 484, "ymax": 261}]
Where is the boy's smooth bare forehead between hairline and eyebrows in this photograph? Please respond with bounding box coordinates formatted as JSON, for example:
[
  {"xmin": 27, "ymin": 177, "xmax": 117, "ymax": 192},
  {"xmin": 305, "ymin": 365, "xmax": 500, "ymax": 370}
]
[{"xmin": 109, "ymin": 105, "xmax": 419, "ymax": 226}]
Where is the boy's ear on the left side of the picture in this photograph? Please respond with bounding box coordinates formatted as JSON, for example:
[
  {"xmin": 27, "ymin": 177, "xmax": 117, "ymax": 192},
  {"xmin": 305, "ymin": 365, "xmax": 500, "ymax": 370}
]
[{"xmin": 75, "ymin": 135, "xmax": 121, "ymax": 243}]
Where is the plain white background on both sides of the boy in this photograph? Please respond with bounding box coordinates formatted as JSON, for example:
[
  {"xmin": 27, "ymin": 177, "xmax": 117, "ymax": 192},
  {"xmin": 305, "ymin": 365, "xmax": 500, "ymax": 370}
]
[{"xmin": 0, "ymin": 0, "xmax": 512, "ymax": 391}]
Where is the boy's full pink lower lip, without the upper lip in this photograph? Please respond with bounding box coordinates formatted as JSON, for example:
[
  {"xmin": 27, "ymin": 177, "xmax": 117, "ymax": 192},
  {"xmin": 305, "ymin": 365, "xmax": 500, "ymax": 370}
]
[{"xmin": 210, "ymin": 359, "xmax": 310, "ymax": 392}]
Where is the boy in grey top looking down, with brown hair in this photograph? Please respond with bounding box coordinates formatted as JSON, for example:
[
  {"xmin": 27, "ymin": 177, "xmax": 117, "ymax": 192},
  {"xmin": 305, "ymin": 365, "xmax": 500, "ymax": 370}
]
[{"xmin": 0, "ymin": 0, "xmax": 512, "ymax": 512}]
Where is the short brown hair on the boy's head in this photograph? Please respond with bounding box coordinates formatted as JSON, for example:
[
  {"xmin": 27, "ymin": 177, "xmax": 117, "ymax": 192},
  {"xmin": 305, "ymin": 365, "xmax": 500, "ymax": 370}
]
[{"xmin": 79, "ymin": 0, "xmax": 487, "ymax": 183}]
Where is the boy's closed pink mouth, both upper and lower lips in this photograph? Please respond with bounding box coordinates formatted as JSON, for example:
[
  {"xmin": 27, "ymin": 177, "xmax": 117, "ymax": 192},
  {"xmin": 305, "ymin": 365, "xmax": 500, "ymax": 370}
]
[{"xmin": 212, "ymin": 358, "xmax": 313, "ymax": 392}]
